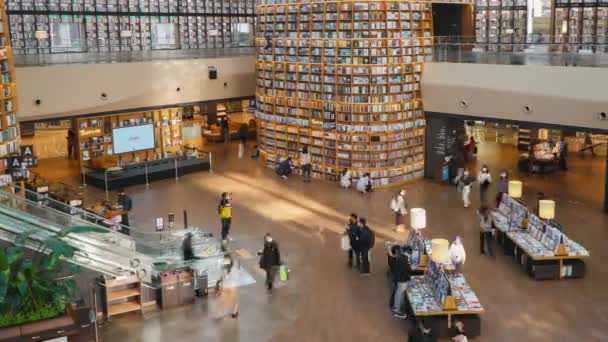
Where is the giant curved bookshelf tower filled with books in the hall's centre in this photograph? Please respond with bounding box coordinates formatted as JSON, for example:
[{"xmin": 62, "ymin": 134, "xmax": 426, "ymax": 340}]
[{"xmin": 256, "ymin": 0, "xmax": 433, "ymax": 186}]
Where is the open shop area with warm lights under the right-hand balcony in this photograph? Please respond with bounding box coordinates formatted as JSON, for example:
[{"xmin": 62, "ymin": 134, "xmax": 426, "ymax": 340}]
[{"xmin": 425, "ymin": 112, "xmax": 608, "ymax": 210}]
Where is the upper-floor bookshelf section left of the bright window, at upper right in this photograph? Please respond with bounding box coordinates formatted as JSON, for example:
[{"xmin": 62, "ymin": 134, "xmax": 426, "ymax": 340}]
[{"xmin": 475, "ymin": 0, "xmax": 528, "ymax": 51}]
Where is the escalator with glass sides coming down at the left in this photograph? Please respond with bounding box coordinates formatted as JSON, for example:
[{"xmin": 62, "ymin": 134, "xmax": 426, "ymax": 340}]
[{"xmin": 0, "ymin": 189, "xmax": 223, "ymax": 283}]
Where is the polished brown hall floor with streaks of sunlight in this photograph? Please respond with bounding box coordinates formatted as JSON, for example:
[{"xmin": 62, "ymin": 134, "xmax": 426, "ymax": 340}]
[{"xmin": 32, "ymin": 142, "xmax": 608, "ymax": 342}]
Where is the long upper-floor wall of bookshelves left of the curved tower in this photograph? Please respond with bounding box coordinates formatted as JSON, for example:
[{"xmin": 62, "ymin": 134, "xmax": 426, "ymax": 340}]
[{"xmin": 7, "ymin": 0, "xmax": 255, "ymax": 54}]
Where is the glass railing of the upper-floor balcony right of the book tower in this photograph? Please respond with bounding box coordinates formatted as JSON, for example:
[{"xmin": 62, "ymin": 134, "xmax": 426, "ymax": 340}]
[{"xmin": 433, "ymin": 36, "xmax": 608, "ymax": 67}]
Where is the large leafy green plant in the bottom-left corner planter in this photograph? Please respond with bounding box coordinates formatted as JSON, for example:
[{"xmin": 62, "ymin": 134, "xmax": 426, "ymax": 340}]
[{"xmin": 0, "ymin": 226, "xmax": 107, "ymax": 327}]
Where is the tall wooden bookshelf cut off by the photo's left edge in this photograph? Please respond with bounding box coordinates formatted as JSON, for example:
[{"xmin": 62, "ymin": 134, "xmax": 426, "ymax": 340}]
[{"xmin": 0, "ymin": 0, "xmax": 19, "ymax": 170}]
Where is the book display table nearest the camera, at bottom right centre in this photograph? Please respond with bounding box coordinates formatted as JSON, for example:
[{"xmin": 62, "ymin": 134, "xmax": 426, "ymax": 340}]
[{"xmin": 406, "ymin": 261, "xmax": 484, "ymax": 337}]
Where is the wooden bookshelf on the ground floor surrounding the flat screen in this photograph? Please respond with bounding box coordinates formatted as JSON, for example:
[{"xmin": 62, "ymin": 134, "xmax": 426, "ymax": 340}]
[{"xmin": 75, "ymin": 108, "xmax": 183, "ymax": 168}]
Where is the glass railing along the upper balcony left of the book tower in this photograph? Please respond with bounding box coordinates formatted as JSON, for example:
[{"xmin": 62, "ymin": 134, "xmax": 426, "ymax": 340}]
[{"xmin": 14, "ymin": 46, "xmax": 254, "ymax": 67}]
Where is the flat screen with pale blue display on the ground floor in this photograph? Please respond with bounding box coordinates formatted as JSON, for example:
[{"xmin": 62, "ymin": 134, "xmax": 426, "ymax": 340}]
[{"xmin": 112, "ymin": 124, "xmax": 154, "ymax": 154}]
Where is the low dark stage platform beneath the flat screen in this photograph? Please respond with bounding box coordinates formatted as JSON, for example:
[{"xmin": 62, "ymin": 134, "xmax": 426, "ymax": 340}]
[{"xmin": 85, "ymin": 157, "xmax": 211, "ymax": 190}]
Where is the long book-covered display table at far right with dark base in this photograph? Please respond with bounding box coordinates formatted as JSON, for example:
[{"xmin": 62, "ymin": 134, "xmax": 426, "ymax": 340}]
[{"xmin": 492, "ymin": 194, "xmax": 590, "ymax": 280}]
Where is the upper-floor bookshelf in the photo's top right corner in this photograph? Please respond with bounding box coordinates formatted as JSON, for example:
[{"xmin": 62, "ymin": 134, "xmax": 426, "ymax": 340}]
[{"xmin": 553, "ymin": 0, "xmax": 608, "ymax": 52}]
